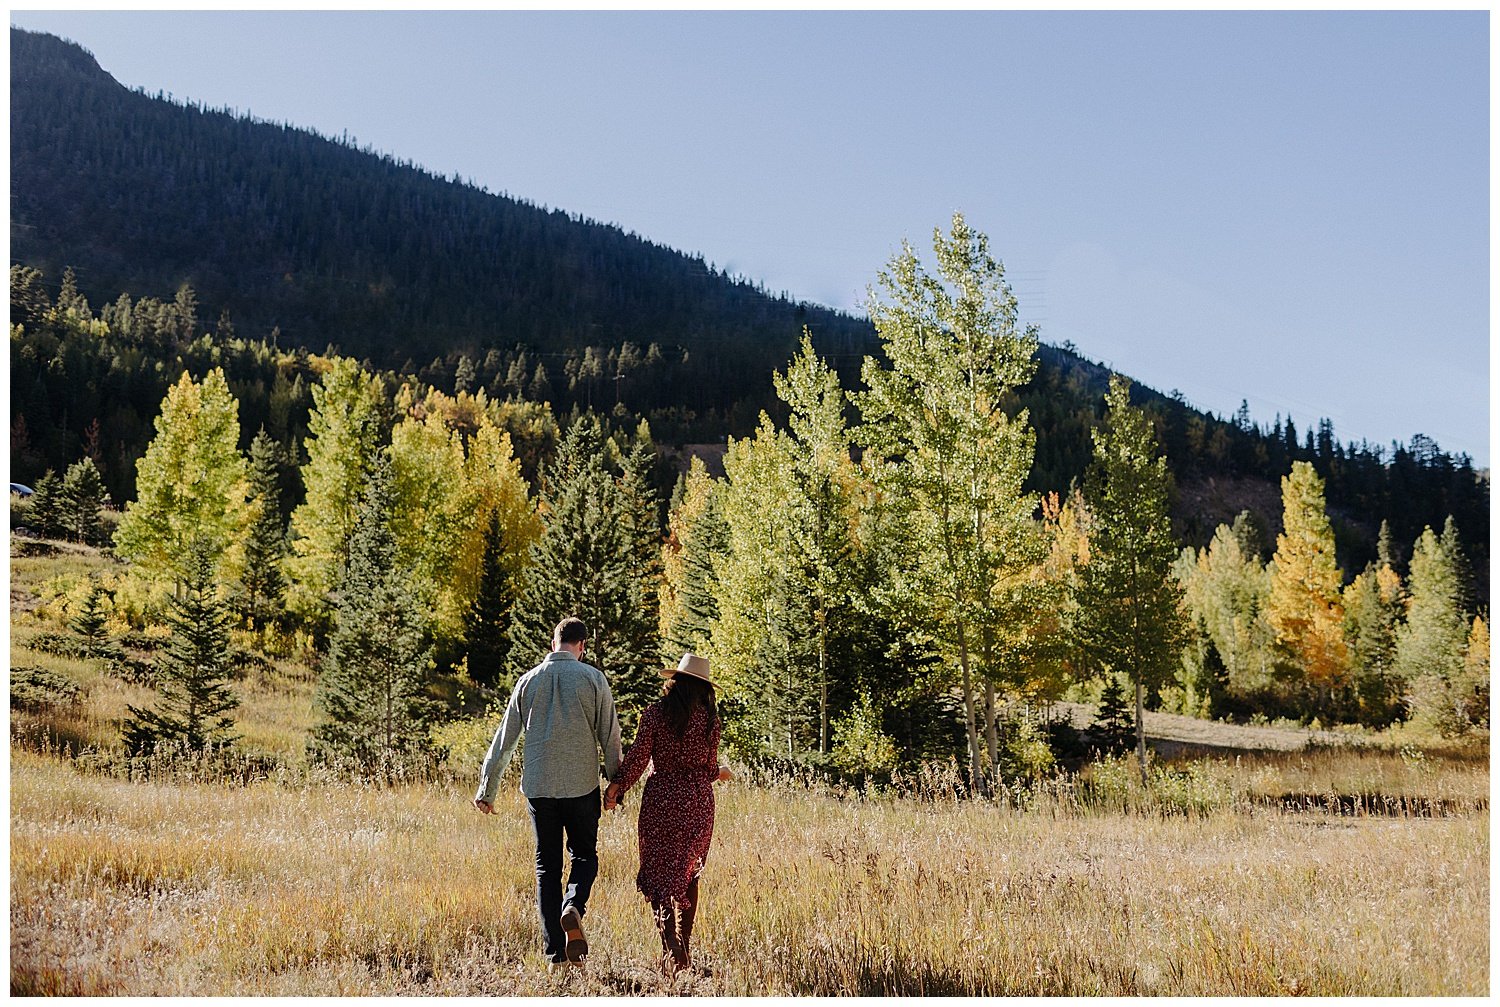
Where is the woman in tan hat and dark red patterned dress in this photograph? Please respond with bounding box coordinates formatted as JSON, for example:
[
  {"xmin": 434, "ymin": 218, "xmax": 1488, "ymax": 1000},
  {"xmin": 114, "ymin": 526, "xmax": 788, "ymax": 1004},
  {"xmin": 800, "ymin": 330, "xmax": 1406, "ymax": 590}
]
[{"xmin": 605, "ymin": 654, "xmax": 731, "ymax": 974}]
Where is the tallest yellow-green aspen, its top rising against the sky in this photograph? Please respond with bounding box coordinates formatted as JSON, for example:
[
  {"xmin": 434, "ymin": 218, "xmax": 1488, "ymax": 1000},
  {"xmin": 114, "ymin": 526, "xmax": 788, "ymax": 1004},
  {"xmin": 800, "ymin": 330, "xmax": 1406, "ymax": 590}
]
[{"xmin": 855, "ymin": 213, "xmax": 1038, "ymax": 786}]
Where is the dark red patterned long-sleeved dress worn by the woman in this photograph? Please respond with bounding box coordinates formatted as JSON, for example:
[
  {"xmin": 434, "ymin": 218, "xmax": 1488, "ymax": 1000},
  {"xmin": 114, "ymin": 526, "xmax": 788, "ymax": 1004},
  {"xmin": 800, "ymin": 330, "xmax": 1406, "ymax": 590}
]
[{"xmin": 615, "ymin": 702, "xmax": 720, "ymax": 902}]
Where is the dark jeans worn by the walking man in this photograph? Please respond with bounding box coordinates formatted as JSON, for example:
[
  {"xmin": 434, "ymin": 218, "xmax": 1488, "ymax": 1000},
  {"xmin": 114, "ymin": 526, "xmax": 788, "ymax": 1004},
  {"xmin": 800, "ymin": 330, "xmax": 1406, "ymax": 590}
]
[{"xmin": 527, "ymin": 788, "xmax": 600, "ymax": 962}]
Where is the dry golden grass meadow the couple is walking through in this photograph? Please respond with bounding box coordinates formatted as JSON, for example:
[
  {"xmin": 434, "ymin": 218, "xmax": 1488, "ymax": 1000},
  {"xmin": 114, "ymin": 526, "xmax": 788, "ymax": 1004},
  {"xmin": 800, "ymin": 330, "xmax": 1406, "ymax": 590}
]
[{"xmin": 9, "ymin": 540, "xmax": 1490, "ymax": 995}]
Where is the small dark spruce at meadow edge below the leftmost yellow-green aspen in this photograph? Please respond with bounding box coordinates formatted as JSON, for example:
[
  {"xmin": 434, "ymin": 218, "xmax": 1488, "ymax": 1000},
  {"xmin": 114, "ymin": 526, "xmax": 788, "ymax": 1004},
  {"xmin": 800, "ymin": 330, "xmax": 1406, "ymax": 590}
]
[{"xmin": 123, "ymin": 540, "xmax": 239, "ymax": 755}]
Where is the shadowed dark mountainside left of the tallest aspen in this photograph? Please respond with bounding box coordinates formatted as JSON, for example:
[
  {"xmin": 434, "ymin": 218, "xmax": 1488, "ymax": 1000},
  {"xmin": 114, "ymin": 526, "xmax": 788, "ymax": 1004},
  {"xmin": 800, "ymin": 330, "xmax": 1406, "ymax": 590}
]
[{"xmin": 11, "ymin": 30, "xmax": 870, "ymax": 420}]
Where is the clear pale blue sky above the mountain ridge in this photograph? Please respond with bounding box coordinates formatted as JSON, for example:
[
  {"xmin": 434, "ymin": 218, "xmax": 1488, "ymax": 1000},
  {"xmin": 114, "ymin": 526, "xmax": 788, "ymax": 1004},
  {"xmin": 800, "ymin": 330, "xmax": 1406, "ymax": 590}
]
[{"xmin": 11, "ymin": 11, "xmax": 1490, "ymax": 465}]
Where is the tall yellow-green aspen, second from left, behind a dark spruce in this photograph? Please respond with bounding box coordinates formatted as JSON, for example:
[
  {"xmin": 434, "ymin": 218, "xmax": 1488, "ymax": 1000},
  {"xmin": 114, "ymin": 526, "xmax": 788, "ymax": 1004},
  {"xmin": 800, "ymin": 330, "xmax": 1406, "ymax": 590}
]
[{"xmin": 285, "ymin": 357, "xmax": 386, "ymax": 621}]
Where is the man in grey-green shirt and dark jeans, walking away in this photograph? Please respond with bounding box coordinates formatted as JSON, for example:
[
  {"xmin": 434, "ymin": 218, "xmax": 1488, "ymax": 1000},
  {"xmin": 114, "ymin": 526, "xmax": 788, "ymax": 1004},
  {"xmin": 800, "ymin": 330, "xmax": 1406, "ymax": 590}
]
[{"xmin": 474, "ymin": 618, "xmax": 620, "ymax": 966}]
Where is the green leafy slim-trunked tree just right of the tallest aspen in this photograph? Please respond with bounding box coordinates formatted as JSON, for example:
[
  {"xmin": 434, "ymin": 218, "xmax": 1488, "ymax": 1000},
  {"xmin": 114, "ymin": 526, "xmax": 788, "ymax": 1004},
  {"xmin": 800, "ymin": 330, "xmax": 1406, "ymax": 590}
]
[{"xmin": 1079, "ymin": 375, "xmax": 1187, "ymax": 782}]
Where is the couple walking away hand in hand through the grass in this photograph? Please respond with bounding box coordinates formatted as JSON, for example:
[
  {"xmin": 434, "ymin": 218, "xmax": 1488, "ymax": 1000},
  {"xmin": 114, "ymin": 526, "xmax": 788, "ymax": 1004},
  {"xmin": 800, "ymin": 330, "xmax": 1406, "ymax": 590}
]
[{"xmin": 474, "ymin": 618, "xmax": 729, "ymax": 974}]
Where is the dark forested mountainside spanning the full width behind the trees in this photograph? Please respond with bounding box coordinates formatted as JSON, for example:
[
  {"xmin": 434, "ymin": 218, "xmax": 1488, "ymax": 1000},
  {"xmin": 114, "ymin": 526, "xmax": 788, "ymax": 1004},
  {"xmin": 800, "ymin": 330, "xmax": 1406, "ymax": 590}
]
[{"xmin": 11, "ymin": 29, "xmax": 1488, "ymax": 596}]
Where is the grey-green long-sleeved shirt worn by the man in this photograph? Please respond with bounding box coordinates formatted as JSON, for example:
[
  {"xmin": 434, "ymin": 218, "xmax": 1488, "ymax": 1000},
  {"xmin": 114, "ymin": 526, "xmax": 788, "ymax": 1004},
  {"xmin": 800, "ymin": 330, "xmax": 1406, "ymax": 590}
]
[{"xmin": 474, "ymin": 650, "xmax": 620, "ymax": 804}]
